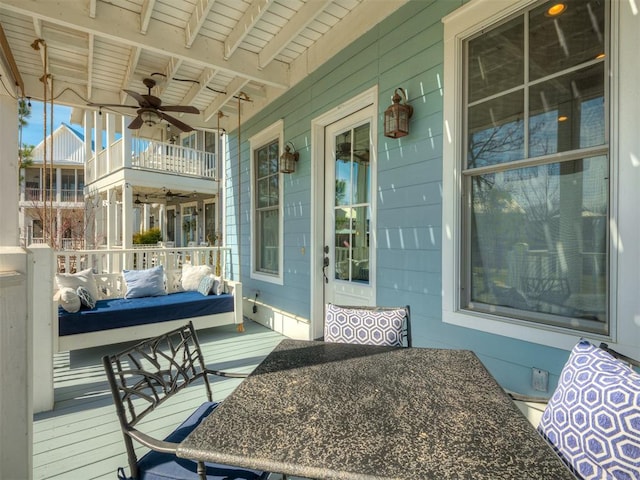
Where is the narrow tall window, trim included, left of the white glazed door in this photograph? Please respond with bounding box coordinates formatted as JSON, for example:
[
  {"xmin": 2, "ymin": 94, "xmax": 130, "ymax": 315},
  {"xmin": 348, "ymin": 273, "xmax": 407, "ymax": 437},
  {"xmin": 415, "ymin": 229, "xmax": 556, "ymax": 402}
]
[{"xmin": 249, "ymin": 122, "xmax": 283, "ymax": 283}]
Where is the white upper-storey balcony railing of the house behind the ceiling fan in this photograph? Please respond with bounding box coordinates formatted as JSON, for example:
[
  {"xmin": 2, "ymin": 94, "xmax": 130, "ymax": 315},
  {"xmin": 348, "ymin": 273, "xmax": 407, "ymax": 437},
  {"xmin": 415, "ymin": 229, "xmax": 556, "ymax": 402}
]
[{"xmin": 85, "ymin": 138, "xmax": 218, "ymax": 183}]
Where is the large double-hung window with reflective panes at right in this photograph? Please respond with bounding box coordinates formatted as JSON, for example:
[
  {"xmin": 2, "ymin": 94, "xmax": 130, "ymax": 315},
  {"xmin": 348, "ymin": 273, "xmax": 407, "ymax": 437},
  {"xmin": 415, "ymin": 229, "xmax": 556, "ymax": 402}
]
[{"xmin": 445, "ymin": 0, "xmax": 610, "ymax": 335}]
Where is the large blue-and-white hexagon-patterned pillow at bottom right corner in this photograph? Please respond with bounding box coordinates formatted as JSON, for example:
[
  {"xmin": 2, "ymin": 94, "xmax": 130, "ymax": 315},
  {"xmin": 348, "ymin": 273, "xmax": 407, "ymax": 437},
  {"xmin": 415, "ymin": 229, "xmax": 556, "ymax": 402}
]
[{"xmin": 538, "ymin": 341, "xmax": 640, "ymax": 480}]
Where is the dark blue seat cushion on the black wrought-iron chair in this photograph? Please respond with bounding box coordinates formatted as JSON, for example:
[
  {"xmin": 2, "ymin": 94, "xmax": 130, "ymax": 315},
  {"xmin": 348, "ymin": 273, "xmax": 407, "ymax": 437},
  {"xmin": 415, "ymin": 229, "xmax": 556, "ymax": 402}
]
[{"xmin": 132, "ymin": 402, "xmax": 268, "ymax": 480}]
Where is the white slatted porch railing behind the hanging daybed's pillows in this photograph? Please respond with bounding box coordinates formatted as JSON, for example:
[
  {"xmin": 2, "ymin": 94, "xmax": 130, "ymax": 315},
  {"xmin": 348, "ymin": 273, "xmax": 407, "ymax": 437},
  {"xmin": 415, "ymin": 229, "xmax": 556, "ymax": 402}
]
[{"xmin": 55, "ymin": 246, "xmax": 231, "ymax": 277}]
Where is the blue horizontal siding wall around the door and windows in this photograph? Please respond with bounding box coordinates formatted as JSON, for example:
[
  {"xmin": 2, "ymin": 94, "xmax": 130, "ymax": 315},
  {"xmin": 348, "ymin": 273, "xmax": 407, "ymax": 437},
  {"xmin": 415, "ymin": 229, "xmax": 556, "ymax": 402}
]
[{"xmin": 225, "ymin": 0, "xmax": 568, "ymax": 393}]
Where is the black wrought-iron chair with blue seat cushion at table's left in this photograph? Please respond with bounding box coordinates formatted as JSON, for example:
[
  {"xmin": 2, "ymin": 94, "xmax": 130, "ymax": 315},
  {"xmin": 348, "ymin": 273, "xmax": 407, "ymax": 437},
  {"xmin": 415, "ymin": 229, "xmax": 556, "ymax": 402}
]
[{"xmin": 102, "ymin": 322, "xmax": 268, "ymax": 480}]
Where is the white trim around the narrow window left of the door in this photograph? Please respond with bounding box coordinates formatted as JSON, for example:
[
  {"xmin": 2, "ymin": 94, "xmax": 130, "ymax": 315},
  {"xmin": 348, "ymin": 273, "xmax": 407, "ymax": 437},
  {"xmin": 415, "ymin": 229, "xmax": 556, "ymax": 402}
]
[{"xmin": 249, "ymin": 120, "xmax": 284, "ymax": 285}]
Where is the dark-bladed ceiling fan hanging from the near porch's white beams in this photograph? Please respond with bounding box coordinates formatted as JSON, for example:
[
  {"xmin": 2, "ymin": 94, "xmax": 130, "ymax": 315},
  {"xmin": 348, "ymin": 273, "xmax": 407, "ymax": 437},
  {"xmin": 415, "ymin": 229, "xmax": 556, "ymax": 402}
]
[{"xmin": 89, "ymin": 78, "xmax": 200, "ymax": 132}]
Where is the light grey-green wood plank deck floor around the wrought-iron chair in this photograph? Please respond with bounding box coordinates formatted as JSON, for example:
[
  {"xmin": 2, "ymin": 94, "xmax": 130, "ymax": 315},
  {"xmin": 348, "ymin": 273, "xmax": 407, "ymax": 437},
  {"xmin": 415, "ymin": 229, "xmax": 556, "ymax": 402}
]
[{"xmin": 33, "ymin": 321, "xmax": 283, "ymax": 480}]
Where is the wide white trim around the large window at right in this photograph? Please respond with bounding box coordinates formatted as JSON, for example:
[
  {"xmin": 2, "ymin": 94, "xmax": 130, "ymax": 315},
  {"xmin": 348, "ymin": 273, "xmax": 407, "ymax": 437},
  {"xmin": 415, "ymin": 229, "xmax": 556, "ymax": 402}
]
[{"xmin": 442, "ymin": 0, "xmax": 617, "ymax": 350}]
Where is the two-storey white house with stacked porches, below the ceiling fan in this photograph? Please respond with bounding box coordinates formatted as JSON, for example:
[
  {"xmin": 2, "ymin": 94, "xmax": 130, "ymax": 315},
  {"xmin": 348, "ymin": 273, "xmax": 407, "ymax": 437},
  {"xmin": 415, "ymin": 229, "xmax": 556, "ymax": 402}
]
[{"xmin": 82, "ymin": 111, "xmax": 223, "ymax": 248}]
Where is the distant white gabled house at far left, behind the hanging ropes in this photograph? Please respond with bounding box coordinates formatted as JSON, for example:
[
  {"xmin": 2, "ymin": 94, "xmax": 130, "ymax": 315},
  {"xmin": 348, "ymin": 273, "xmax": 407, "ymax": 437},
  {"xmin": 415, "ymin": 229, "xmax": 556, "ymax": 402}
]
[{"xmin": 18, "ymin": 123, "xmax": 86, "ymax": 249}]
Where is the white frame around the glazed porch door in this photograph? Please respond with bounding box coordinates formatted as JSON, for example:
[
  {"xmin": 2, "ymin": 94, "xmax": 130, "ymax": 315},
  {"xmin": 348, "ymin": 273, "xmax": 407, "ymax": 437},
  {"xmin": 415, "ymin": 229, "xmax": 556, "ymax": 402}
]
[{"xmin": 309, "ymin": 85, "xmax": 378, "ymax": 339}]
